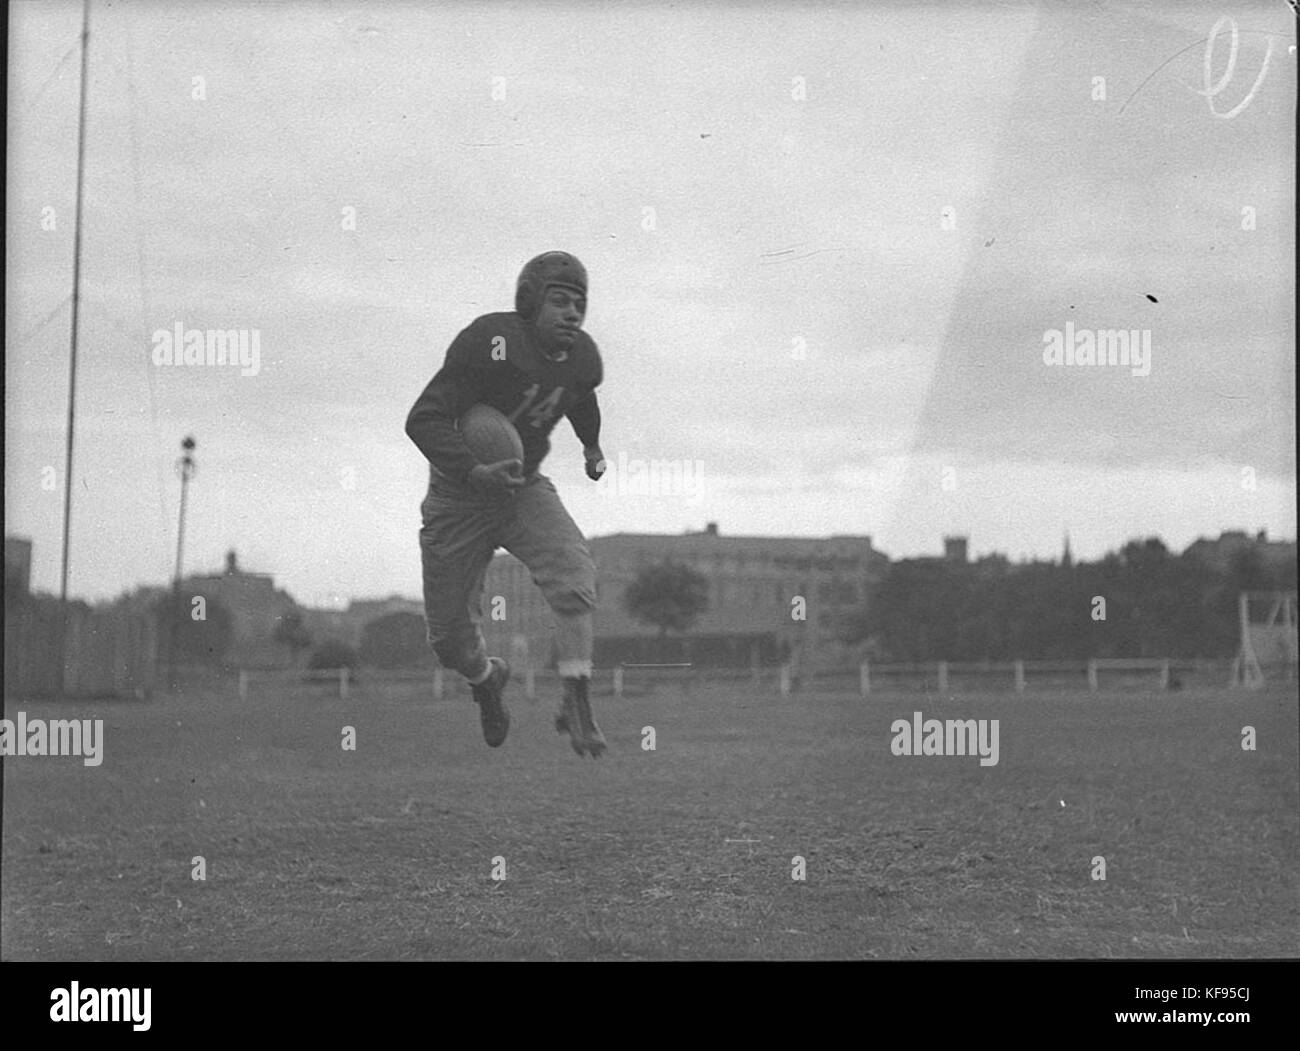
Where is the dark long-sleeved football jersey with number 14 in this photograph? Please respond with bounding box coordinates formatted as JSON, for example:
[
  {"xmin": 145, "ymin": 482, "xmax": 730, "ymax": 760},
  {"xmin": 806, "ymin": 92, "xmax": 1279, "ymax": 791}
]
[{"xmin": 406, "ymin": 311, "xmax": 603, "ymax": 483}]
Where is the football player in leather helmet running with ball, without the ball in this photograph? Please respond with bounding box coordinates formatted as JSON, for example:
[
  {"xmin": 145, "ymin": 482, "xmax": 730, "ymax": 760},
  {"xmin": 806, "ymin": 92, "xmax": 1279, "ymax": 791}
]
[{"xmin": 406, "ymin": 252, "xmax": 606, "ymax": 757}]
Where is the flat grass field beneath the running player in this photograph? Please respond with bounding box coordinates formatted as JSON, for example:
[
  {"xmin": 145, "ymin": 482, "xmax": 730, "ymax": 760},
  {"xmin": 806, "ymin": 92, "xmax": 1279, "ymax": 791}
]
[{"xmin": 0, "ymin": 682, "xmax": 1300, "ymax": 960}]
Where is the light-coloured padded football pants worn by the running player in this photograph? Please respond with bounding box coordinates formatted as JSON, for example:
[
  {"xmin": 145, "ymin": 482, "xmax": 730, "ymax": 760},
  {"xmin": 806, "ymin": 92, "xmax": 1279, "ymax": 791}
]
[{"xmin": 420, "ymin": 473, "xmax": 595, "ymax": 678}]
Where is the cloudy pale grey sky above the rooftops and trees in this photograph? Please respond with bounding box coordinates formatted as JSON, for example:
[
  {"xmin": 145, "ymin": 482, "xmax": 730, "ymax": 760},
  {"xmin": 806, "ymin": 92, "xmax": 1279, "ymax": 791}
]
[{"xmin": 5, "ymin": 0, "xmax": 1296, "ymax": 605}]
